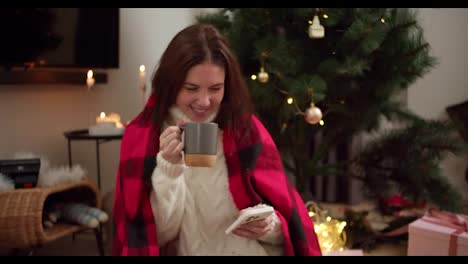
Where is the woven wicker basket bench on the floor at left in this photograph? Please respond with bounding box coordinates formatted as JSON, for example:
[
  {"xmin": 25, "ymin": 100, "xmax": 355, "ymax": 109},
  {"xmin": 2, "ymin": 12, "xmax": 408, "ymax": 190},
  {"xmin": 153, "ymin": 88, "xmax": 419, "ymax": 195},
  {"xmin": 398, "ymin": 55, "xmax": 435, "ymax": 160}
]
[{"xmin": 0, "ymin": 180, "xmax": 101, "ymax": 248}]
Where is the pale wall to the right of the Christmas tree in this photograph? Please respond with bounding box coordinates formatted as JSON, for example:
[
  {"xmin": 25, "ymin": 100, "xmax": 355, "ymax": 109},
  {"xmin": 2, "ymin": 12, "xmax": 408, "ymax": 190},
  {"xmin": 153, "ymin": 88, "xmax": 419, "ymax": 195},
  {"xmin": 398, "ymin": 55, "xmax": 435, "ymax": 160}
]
[{"xmin": 408, "ymin": 8, "xmax": 468, "ymax": 204}]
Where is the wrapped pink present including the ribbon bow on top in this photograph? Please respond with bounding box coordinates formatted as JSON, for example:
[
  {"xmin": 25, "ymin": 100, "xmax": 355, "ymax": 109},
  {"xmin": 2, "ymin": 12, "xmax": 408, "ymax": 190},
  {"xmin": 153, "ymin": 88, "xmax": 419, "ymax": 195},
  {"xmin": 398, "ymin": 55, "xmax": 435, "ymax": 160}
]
[{"xmin": 408, "ymin": 209, "xmax": 468, "ymax": 256}]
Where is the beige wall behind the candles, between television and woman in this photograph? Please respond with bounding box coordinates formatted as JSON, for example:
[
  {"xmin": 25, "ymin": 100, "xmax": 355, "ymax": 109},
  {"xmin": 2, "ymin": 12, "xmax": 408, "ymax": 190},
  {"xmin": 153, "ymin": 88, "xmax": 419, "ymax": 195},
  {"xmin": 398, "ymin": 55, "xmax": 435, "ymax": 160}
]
[{"xmin": 0, "ymin": 8, "xmax": 196, "ymax": 192}]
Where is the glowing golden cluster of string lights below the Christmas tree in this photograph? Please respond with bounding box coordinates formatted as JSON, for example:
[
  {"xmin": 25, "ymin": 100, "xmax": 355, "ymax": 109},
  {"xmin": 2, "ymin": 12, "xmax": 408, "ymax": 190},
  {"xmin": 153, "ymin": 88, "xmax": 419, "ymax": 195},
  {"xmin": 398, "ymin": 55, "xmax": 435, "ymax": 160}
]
[{"xmin": 305, "ymin": 201, "xmax": 346, "ymax": 253}]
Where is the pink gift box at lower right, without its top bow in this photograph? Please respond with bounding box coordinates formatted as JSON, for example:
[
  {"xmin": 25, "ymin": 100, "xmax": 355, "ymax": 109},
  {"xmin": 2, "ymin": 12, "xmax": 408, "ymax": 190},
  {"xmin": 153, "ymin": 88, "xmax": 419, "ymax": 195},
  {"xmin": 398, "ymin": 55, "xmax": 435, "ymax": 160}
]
[{"xmin": 408, "ymin": 216, "xmax": 468, "ymax": 256}]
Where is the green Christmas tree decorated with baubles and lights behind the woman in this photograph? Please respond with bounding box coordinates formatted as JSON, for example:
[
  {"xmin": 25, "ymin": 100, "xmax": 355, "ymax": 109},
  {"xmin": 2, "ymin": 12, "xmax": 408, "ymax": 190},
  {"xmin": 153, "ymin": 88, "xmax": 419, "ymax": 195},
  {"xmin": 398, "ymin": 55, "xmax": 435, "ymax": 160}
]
[{"xmin": 197, "ymin": 8, "xmax": 462, "ymax": 211}]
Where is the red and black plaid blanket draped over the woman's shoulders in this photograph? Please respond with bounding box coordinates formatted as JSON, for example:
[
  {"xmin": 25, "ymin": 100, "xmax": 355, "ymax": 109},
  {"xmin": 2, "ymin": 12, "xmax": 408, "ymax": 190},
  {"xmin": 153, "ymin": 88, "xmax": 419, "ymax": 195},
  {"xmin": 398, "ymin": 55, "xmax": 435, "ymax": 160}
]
[{"xmin": 112, "ymin": 95, "xmax": 321, "ymax": 256}]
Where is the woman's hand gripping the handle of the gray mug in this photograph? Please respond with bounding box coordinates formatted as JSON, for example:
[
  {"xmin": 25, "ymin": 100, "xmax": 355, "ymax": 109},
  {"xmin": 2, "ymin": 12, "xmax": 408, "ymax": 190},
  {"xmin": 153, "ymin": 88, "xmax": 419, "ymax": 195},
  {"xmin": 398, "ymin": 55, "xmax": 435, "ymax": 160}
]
[{"xmin": 159, "ymin": 123, "xmax": 184, "ymax": 164}]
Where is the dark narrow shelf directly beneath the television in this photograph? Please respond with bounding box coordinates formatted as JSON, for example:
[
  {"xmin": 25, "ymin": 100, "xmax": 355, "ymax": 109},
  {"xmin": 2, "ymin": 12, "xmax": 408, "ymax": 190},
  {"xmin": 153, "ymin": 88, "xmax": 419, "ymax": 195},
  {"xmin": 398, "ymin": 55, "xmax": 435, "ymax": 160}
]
[{"xmin": 0, "ymin": 69, "xmax": 107, "ymax": 85}]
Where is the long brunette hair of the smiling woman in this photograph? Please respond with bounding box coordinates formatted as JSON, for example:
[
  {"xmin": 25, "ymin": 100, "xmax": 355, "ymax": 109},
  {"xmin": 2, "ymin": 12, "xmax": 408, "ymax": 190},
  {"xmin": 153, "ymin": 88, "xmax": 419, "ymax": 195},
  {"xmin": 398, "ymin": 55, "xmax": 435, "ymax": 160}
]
[{"xmin": 152, "ymin": 24, "xmax": 253, "ymax": 131}]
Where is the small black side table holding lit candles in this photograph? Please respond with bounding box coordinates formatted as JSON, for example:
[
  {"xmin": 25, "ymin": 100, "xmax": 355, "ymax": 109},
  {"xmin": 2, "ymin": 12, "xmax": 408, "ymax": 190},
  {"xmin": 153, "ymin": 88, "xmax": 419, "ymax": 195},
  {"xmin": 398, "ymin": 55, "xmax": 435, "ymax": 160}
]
[{"xmin": 63, "ymin": 129, "xmax": 122, "ymax": 190}]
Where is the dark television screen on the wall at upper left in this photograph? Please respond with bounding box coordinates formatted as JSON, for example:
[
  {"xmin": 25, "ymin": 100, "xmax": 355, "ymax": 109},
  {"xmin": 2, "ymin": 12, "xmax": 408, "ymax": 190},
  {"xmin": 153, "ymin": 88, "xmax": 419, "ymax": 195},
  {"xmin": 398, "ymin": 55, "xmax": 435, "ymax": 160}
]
[{"xmin": 0, "ymin": 8, "xmax": 119, "ymax": 69}]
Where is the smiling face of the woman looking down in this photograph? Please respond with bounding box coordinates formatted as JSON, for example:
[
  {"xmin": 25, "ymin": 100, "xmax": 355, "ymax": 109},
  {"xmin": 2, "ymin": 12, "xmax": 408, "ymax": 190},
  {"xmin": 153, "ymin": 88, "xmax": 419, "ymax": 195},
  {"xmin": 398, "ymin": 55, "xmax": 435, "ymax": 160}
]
[{"xmin": 176, "ymin": 63, "xmax": 226, "ymax": 122}]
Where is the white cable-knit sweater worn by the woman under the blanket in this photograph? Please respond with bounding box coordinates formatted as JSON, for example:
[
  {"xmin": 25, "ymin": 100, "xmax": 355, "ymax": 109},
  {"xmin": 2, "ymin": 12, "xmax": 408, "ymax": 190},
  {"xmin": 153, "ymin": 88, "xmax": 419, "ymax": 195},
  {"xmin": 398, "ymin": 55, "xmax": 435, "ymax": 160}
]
[{"xmin": 151, "ymin": 107, "xmax": 283, "ymax": 256}]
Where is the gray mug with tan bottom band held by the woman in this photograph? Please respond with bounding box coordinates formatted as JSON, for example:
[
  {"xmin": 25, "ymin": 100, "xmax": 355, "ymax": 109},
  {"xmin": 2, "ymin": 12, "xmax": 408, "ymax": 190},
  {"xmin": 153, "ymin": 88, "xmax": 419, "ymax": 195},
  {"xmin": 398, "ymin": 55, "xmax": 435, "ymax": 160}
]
[{"xmin": 181, "ymin": 122, "xmax": 218, "ymax": 167}]
